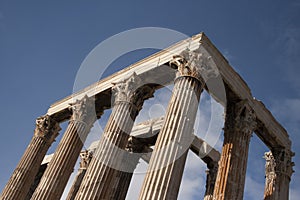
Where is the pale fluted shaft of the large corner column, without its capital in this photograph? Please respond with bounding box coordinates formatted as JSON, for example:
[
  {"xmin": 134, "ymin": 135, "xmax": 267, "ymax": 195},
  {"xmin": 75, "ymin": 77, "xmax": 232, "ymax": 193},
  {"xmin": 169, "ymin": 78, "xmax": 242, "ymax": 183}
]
[{"xmin": 139, "ymin": 76, "xmax": 204, "ymax": 200}]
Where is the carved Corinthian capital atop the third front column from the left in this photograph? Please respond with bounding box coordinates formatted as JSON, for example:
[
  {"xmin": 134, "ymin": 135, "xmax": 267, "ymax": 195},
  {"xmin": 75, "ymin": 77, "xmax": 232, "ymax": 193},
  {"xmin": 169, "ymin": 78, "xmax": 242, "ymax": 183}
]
[{"xmin": 112, "ymin": 73, "xmax": 154, "ymax": 109}]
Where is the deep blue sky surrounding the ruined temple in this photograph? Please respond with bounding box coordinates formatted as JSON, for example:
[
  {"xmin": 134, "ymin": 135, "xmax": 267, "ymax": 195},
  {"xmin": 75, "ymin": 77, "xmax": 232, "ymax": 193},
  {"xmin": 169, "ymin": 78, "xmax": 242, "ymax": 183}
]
[{"xmin": 0, "ymin": 0, "xmax": 300, "ymax": 199}]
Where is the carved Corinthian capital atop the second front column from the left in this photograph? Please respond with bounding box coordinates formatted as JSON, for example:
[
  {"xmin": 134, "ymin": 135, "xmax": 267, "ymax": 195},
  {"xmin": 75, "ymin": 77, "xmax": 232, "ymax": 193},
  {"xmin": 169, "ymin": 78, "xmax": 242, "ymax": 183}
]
[{"xmin": 70, "ymin": 95, "xmax": 96, "ymax": 125}]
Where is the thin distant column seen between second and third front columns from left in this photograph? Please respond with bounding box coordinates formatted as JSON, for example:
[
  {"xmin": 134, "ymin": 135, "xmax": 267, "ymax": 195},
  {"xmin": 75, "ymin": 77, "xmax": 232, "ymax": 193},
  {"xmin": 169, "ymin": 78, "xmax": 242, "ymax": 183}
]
[{"xmin": 66, "ymin": 150, "xmax": 93, "ymax": 200}]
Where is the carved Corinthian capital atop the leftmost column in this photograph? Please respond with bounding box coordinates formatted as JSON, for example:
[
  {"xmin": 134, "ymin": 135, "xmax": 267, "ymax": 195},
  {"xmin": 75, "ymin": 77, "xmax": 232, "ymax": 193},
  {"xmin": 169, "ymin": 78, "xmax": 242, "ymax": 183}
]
[{"xmin": 34, "ymin": 115, "xmax": 61, "ymax": 142}]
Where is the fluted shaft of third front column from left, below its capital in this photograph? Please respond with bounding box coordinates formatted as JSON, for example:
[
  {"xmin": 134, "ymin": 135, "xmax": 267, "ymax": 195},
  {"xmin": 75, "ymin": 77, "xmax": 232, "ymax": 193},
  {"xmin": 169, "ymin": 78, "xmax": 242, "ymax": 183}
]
[{"xmin": 75, "ymin": 103, "xmax": 133, "ymax": 200}]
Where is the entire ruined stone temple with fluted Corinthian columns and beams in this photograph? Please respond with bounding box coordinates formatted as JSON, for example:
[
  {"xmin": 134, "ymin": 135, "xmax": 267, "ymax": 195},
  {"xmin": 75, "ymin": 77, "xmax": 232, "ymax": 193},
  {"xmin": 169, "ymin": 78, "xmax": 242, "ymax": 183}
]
[{"xmin": 1, "ymin": 33, "xmax": 294, "ymax": 200}]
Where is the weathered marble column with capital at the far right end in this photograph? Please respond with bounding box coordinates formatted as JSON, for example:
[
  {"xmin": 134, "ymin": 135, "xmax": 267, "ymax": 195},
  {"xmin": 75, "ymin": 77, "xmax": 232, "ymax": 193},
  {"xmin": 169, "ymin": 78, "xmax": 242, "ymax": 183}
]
[{"xmin": 264, "ymin": 148, "xmax": 294, "ymax": 200}]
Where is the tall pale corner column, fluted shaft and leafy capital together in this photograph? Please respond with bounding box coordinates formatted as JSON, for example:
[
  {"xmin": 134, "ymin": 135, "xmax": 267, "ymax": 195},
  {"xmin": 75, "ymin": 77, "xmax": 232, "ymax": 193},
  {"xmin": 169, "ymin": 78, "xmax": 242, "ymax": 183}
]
[{"xmin": 139, "ymin": 49, "xmax": 217, "ymax": 200}]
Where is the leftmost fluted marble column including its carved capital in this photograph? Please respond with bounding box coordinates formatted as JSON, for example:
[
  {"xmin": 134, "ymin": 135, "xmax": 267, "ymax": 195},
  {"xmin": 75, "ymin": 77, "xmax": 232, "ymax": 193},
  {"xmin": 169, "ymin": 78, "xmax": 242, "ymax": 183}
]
[{"xmin": 0, "ymin": 115, "xmax": 61, "ymax": 200}]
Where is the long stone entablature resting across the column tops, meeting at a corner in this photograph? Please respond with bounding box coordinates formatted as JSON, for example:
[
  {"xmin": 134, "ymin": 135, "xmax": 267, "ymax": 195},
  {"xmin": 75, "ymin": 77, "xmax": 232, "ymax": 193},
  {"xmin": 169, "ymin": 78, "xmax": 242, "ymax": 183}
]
[{"xmin": 47, "ymin": 33, "xmax": 291, "ymax": 149}]
